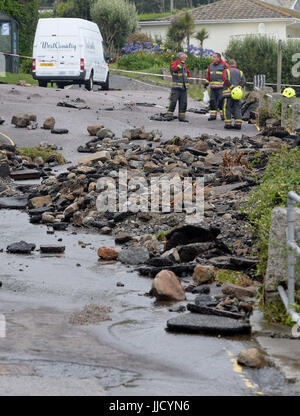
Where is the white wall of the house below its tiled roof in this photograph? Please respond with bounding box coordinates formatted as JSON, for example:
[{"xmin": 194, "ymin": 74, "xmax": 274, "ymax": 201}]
[{"xmin": 140, "ymin": 22, "xmax": 287, "ymax": 54}]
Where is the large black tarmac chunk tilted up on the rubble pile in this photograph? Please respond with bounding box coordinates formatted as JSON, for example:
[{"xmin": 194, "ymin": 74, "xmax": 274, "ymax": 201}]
[{"xmin": 166, "ymin": 224, "xmax": 220, "ymax": 250}]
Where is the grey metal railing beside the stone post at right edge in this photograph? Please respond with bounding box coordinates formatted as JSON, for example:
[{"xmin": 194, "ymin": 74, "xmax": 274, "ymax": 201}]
[{"xmin": 278, "ymin": 192, "xmax": 300, "ymax": 325}]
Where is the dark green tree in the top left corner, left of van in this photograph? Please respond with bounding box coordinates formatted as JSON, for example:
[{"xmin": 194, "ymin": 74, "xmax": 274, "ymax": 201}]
[{"xmin": 0, "ymin": 0, "xmax": 39, "ymax": 56}]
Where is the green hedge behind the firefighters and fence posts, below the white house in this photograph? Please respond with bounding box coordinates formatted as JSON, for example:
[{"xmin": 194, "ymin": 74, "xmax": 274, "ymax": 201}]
[{"xmin": 225, "ymin": 35, "xmax": 300, "ymax": 87}]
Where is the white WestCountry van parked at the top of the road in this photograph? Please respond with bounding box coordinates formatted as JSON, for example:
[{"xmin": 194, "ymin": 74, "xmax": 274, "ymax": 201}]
[{"xmin": 32, "ymin": 18, "xmax": 109, "ymax": 91}]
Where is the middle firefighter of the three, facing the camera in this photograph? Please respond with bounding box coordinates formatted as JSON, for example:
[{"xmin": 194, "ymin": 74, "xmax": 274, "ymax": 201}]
[{"xmin": 206, "ymin": 53, "xmax": 228, "ymax": 121}]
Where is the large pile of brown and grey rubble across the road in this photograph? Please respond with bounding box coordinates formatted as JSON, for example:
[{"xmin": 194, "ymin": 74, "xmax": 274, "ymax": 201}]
[{"xmin": 2, "ymin": 125, "xmax": 295, "ymax": 319}]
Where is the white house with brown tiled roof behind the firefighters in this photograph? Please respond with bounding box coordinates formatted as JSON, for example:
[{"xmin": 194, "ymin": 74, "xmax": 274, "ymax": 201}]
[{"xmin": 139, "ymin": 0, "xmax": 300, "ymax": 53}]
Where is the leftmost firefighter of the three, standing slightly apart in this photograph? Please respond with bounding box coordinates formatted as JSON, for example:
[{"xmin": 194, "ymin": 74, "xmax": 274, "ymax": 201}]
[{"xmin": 166, "ymin": 52, "xmax": 190, "ymax": 122}]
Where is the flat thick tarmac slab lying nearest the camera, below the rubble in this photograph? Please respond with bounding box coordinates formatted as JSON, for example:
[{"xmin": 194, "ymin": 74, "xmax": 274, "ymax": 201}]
[{"xmin": 167, "ymin": 313, "xmax": 251, "ymax": 335}]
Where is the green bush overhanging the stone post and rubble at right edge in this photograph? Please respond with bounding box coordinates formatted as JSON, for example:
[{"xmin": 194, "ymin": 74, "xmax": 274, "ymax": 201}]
[{"xmin": 243, "ymin": 147, "xmax": 300, "ymax": 275}]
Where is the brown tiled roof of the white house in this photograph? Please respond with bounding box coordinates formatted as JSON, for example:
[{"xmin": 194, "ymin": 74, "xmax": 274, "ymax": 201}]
[{"xmin": 158, "ymin": 0, "xmax": 300, "ymax": 23}]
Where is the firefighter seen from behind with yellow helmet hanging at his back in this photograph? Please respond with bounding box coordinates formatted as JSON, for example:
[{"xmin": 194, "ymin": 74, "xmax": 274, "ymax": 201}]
[{"xmin": 223, "ymin": 59, "xmax": 246, "ymax": 130}]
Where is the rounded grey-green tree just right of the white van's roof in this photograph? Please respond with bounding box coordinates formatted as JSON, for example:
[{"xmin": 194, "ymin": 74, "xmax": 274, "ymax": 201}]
[{"xmin": 91, "ymin": 0, "xmax": 138, "ymax": 53}]
